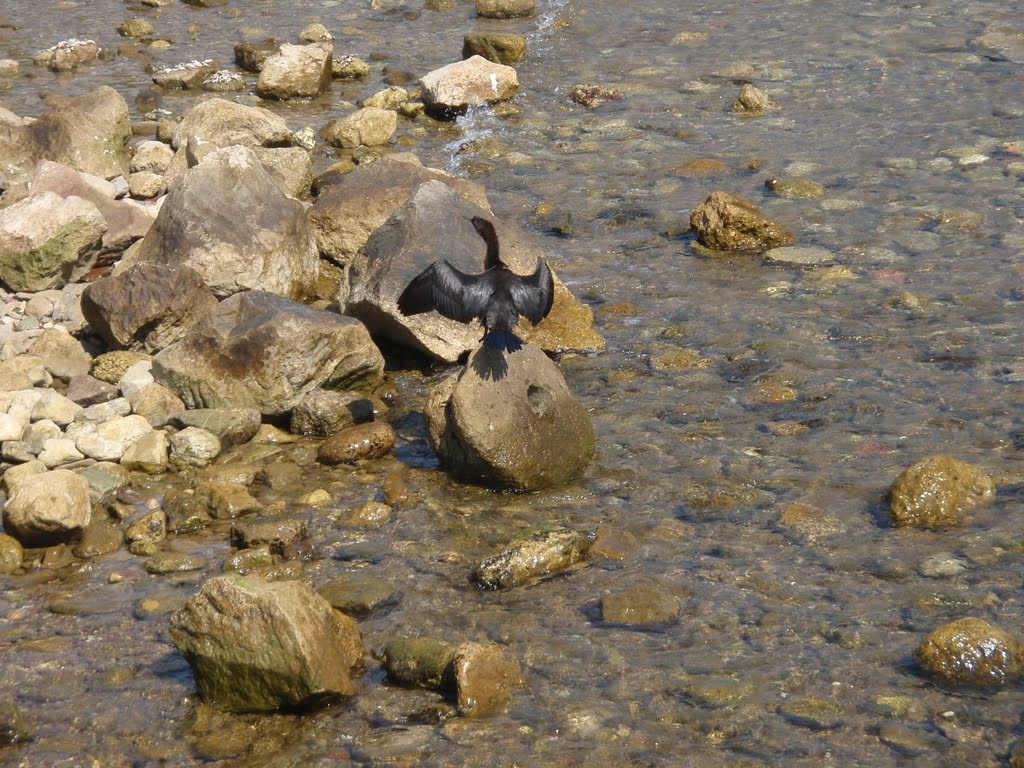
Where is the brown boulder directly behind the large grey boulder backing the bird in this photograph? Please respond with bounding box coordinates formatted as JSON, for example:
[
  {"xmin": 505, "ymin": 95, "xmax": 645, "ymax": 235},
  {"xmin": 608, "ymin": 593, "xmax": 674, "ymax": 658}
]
[{"xmin": 308, "ymin": 158, "xmax": 490, "ymax": 267}]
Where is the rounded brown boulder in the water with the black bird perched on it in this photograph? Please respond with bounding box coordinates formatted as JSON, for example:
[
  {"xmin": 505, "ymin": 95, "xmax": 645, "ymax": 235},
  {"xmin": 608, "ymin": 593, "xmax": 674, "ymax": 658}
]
[{"xmin": 425, "ymin": 344, "xmax": 594, "ymax": 490}]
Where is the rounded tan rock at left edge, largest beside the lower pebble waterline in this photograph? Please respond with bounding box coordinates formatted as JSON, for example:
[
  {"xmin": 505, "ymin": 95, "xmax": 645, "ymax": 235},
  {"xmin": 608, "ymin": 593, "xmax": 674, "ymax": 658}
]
[{"xmin": 3, "ymin": 469, "xmax": 92, "ymax": 547}]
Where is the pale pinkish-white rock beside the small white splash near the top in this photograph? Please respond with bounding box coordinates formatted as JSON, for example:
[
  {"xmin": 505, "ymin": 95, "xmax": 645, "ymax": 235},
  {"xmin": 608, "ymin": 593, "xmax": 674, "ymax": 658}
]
[{"xmin": 420, "ymin": 56, "xmax": 519, "ymax": 118}]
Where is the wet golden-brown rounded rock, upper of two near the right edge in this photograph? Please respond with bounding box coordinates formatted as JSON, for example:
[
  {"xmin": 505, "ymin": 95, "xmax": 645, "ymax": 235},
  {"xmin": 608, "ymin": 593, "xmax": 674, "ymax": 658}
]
[{"xmin": 889, "ymin": 456, "xmax": 995, "ymax": 528}]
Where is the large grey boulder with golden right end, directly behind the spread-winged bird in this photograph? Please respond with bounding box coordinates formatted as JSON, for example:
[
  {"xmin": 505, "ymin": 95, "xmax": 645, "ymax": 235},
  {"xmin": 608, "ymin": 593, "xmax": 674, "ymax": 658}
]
[{"xmin": 339, "ymin": 181, "xmax": 603, "ymax": 362}]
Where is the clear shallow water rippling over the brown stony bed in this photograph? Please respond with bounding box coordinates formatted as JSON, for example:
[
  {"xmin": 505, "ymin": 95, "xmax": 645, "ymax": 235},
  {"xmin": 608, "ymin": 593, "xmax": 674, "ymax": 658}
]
[{"xmin": 0, "ymin": 0, "xmax": 1024, "ymax": 766}]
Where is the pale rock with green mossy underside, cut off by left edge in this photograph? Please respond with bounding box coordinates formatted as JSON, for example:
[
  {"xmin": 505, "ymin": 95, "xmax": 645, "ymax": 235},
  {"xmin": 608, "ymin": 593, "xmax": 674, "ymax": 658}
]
[{"xmin": 0, "ymin": 193, "xmax": 106, "ymax": 291}]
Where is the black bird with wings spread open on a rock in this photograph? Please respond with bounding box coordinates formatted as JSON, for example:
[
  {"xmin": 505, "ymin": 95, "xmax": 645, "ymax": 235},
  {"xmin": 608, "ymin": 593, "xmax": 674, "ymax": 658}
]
[{"xmin": 398, "ymin": 216, "xmax": 555, "ymax": 352}]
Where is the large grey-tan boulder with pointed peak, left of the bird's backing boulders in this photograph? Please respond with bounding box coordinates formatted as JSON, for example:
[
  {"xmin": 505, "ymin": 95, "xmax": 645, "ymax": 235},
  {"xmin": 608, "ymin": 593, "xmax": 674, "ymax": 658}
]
[{"xmin": 135, "ymin": 145, "xmax": 318, "ymax": 300}]
